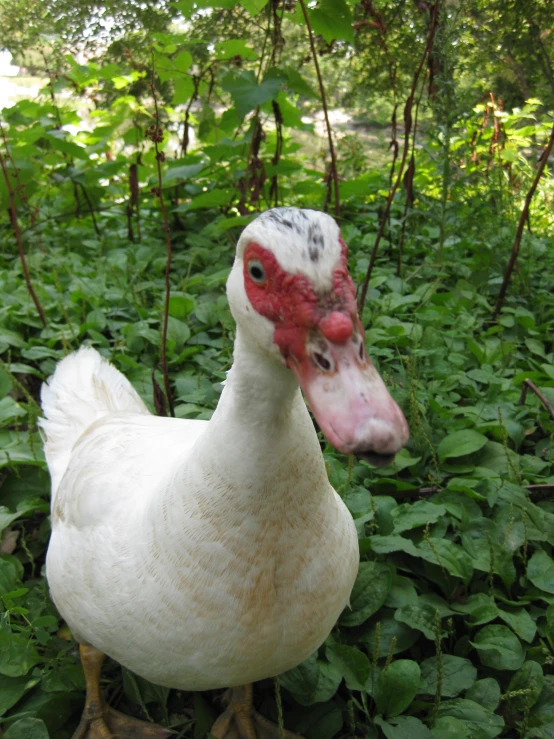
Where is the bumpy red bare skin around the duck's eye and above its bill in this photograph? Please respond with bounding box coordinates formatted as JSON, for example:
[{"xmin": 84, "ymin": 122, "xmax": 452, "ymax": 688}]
[{"xmin": 244, "ymin": 238, "xmax": 363, "ymax": 366}]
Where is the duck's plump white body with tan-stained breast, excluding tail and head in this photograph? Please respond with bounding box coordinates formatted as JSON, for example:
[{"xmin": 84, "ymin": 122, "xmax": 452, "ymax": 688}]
[{"xmin": 47, "ymin": 349, "xmax": 359, "ymax": 690}]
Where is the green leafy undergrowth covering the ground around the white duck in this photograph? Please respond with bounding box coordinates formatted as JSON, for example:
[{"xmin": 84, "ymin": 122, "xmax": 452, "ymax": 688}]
[{"xmin": 0, "ymin": 2, "xmax": 554, "ymax": 739}]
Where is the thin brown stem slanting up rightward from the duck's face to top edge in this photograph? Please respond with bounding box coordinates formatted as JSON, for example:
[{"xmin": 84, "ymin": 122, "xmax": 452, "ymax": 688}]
[{"xmin": 358, "ymin": 0, "xmax": 441, "ymax": 315}]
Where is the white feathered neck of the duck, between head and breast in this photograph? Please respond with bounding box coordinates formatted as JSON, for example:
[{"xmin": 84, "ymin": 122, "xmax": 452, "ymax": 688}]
[{"xmin": 195, "ymin": 331, "xmax": 327, "ymax": 497}]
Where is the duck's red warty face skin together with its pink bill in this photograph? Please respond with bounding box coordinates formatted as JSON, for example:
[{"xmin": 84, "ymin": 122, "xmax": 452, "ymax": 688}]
[{"xmin": 239, "ymin": 239, "xmax": 408, "ymax": 463}]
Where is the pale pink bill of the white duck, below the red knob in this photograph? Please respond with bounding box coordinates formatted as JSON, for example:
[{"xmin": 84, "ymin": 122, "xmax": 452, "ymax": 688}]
[{"xmin": 290, "ymin": 339, "xmax": 409, "ymax": 466}]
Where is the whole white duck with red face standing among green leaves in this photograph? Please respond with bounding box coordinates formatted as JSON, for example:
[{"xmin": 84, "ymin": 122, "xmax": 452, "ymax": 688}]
[{"xmin": 41, "ymin": 208, "xmax": 408, "ymax": 739}]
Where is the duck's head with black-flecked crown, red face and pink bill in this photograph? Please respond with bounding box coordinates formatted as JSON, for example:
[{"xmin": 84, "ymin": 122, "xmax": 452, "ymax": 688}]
[{"xmin": 227, "ymin": 208, "xmax": 408, "ymax": 466}]
